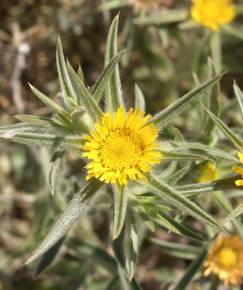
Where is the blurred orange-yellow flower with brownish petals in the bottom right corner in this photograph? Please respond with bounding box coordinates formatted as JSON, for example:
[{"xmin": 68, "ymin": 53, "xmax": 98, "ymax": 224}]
[{"xmin": 204, "ymin": 235, "xmax": 243, "ymax": 285}]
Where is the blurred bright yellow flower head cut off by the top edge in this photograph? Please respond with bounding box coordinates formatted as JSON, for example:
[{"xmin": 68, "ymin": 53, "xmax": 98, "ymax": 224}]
[{"xmin": 191, "ymin": 0, "xmax": 236, "ymax": 31}]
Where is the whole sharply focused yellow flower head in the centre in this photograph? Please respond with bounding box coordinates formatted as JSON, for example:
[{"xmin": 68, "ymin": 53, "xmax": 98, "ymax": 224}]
[{"xmin": 84, "ymin": 107, "xmax": 161, "ymax": 185}]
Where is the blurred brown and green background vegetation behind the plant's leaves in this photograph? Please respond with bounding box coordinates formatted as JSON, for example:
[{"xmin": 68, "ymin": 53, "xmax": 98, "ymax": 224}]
[{"xmin": 0, "ymin": 0, "xmax": 243, "ymax": 290}]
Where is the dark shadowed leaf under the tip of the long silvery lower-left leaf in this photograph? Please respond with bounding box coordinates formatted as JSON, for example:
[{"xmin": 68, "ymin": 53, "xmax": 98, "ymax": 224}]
[{"xmin": 34, "ymin": 238, "xmax": 65, "ymax": 278}]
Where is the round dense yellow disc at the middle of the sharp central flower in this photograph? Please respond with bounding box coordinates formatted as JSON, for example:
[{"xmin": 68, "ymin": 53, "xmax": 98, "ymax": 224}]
[{"xmin": 100, "ymin": 129, "xmax": 143, "ymax": 170}]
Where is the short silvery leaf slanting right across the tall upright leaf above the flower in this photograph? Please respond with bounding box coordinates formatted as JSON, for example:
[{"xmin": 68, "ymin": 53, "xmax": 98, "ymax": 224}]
[{"xmin": 92, "ymin": 51, "xmax": 124, "ymax": 102}]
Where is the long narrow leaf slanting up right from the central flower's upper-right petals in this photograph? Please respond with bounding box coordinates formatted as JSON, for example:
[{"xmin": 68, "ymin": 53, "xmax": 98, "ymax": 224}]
[{"xmin": 150, "ymin": 74, "xmax": 222, "ymax": 128}]
